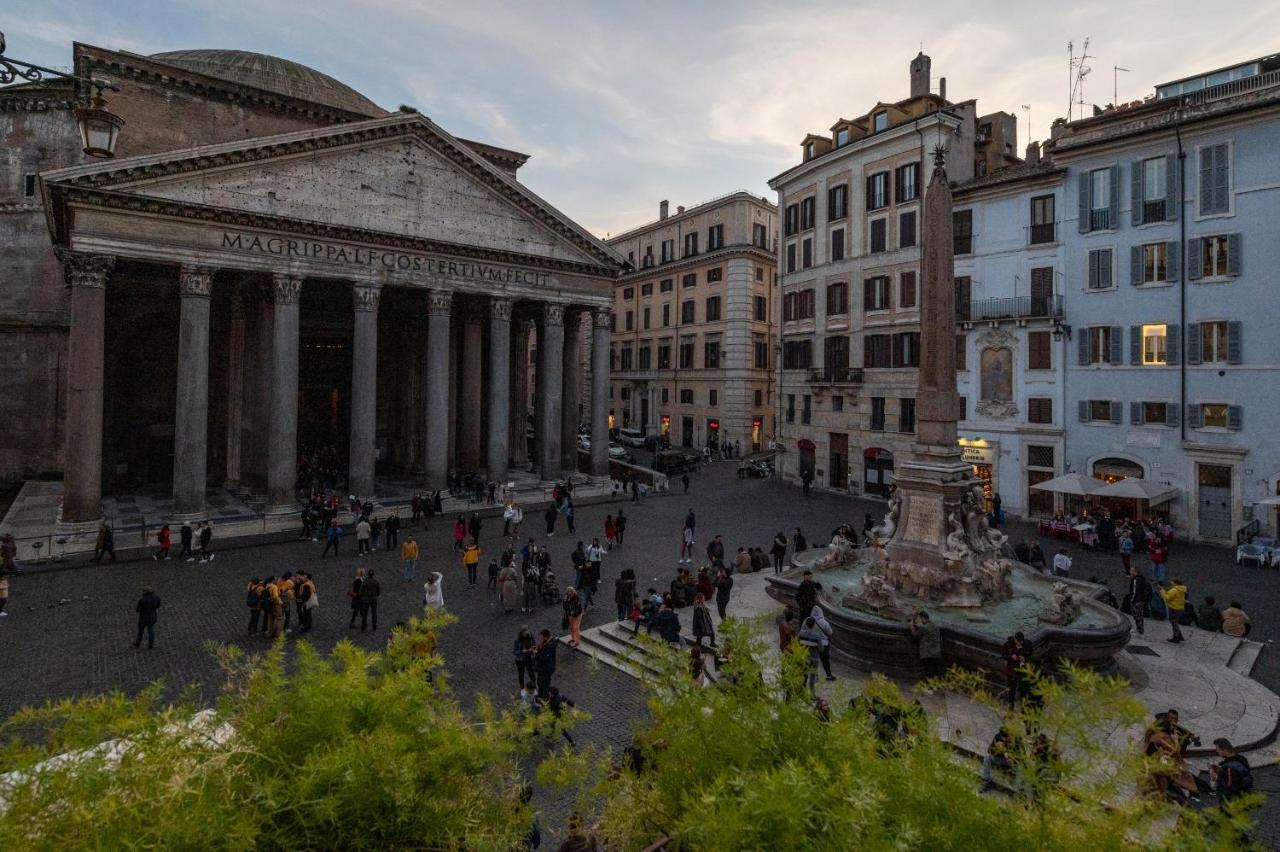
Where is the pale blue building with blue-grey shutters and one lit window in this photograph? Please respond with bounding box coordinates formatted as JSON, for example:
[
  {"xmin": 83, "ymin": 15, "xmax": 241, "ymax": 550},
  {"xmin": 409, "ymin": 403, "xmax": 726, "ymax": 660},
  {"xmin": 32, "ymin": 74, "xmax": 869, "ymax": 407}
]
[{"xmin": 1052, "ymin": 55, "xmax": 1280, "ymax": 541}]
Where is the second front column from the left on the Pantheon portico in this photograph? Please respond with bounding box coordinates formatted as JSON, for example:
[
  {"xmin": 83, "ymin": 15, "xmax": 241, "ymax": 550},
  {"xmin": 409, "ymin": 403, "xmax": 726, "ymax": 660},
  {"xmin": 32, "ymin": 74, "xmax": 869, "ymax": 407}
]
[{"xmin": 170, "ymin": 266, "xmax": 214, "ymax": 523}]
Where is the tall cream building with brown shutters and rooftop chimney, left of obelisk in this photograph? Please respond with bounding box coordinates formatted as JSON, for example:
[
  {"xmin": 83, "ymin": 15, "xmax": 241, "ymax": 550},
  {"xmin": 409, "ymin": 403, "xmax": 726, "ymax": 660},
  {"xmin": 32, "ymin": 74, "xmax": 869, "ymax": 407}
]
[{"xmin": 769, "ymin": 54, "xmax": 1019, "ymax": 496}]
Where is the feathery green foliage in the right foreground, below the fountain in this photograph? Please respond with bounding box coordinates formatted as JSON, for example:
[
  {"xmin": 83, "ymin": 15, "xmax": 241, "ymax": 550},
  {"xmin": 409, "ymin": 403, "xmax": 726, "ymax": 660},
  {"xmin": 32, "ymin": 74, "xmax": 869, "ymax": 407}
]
[{"xmin": 539, "ymin": 616, "xmax": 1244, "ymax": 852}]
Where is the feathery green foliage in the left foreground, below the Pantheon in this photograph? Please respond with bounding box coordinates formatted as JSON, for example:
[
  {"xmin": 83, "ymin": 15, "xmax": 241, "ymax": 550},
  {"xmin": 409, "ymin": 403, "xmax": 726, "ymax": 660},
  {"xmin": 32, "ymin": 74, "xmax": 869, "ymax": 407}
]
[{"xmin": 0, "ymin": 615, "xmax": 532, "ymax": 849}]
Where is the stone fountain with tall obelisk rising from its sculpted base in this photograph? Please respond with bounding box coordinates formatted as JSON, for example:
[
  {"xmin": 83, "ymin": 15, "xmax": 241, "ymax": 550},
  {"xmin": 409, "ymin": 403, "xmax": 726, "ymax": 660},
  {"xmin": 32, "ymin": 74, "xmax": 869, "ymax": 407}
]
[{"xmin": 769, "ymin": 147, "xmax": 1129, "ymax": 674}]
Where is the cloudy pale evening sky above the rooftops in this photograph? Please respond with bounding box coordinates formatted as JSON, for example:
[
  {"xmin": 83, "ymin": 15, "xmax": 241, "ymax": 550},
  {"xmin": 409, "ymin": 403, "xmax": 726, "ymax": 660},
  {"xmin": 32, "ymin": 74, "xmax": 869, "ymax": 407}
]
[{"xmin": 12, "ymin": 0, "xmax": 1280, "ymax": 237}]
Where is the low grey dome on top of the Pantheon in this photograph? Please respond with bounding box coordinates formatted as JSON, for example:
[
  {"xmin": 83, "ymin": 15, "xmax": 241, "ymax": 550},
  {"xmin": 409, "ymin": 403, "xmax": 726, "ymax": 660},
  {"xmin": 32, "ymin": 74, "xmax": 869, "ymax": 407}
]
[{"xmin": 151, "ymin": 50, "xmax": 387, "ymax": 118}]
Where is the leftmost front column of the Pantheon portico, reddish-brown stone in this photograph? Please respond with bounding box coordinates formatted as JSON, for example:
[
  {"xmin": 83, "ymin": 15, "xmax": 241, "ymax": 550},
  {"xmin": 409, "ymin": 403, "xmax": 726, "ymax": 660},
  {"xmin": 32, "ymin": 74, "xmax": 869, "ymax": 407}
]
[{"xmin": 58, "ymin": 248, "xmax": 115, "ymax": 527}]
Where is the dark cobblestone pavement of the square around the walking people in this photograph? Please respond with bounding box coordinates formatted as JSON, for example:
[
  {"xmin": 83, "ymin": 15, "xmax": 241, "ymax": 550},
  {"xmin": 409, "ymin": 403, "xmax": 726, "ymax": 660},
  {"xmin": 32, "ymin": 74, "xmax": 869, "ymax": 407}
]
[{"xmin": 0, "ymin": 463, "xmax": 1280, "ymax": 843}]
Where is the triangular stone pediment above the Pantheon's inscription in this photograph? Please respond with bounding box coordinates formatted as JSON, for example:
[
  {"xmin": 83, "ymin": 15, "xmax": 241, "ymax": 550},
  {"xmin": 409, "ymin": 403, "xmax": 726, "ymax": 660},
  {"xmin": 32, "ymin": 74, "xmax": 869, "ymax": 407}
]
[{"xmin": 46, "ymin": 115, "xmax": 620, "ymax": 266}]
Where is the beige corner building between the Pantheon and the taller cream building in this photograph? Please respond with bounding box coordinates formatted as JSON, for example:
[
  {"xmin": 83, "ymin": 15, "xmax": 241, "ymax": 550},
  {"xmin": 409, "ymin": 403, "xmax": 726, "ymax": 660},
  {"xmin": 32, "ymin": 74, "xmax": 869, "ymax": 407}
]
[{"xmin": 607, "ymin": 192, "xmax": 777, "ymax": 453}]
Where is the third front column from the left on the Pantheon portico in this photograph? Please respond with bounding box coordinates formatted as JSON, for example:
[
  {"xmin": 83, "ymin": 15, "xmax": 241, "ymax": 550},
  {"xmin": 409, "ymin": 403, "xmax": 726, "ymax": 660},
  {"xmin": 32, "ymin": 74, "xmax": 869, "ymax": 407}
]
[{"xmin": 266, "ymin": 274, "xmax": 302, "ymax": 514}]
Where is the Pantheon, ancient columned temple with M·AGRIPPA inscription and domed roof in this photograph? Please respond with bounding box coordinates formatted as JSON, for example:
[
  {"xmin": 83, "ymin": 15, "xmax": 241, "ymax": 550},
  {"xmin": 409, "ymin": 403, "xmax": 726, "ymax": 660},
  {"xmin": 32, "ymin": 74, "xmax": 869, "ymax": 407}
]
[{"xmin": 0, "ymin": 43, "xmax": 622, "ymax": 526}]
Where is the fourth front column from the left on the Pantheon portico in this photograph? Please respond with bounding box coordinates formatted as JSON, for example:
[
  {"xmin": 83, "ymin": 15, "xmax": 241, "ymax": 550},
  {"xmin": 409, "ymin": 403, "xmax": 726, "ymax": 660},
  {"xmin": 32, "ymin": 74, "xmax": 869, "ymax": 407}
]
[{"xmin": 347, "ymin": 284, "xmax": 381, "ymax": 498}]
